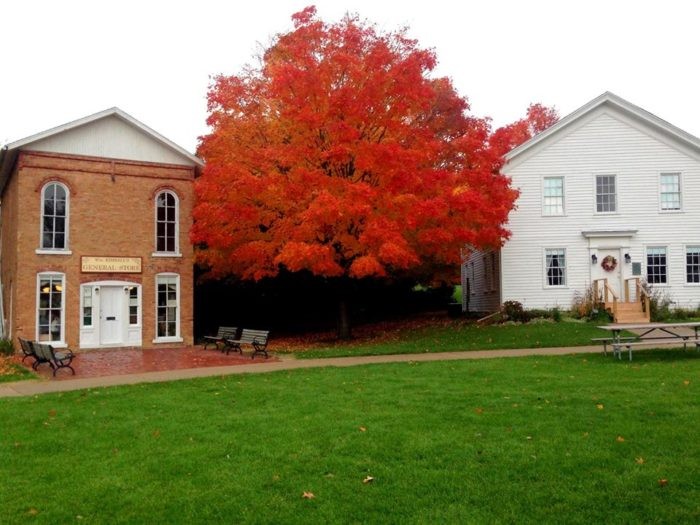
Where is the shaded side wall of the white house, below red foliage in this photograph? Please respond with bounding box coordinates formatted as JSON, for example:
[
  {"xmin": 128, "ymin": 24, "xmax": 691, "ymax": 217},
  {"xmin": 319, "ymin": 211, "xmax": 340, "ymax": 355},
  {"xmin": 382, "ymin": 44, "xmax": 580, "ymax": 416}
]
[{"xmin": 462, "ymin": 250, "xmax": 501, "ymax": 312}]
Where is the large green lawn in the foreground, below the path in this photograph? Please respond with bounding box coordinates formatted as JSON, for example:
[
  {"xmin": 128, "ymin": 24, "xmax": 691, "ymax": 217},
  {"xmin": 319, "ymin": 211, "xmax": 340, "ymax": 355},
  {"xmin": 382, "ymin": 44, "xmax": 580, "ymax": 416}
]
[{"xmin": 0, "ymin": 350, "xmax": 700, "ymax": 524}]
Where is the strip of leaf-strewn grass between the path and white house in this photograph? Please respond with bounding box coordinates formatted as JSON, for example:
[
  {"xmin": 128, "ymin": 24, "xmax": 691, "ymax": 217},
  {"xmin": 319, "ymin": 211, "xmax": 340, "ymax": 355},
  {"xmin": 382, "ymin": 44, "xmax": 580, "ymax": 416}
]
[{"xmin": 295, "ymin": 321, "xmax": 610, "ymax": 359}]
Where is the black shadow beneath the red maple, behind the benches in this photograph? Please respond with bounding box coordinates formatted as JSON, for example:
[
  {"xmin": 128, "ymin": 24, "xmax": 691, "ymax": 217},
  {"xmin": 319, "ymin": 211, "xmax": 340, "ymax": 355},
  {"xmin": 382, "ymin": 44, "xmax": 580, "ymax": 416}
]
[{"xmin": 194, "ymin": 272, "xmax": 452, "ymax": 339}]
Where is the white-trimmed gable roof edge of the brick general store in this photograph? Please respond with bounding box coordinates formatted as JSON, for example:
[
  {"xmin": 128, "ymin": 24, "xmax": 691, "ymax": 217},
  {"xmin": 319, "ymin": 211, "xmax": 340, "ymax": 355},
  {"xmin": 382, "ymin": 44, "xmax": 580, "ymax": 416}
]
[{"xmin": 0, "ymin": 107, "xmax": 204, "ymax": 193}]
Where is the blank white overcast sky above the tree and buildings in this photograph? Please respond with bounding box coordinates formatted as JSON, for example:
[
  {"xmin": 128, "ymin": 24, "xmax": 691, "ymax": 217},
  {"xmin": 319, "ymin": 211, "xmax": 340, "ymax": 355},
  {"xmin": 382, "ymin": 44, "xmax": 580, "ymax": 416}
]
[{"xmin": 0, "ymin": 0, "xmax": 700, "ymax": 151}]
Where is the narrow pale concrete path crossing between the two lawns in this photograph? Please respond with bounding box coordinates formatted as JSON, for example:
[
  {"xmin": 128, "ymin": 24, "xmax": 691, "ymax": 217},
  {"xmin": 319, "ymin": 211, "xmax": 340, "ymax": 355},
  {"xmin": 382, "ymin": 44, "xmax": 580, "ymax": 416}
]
[{"xmin": 0, "ymin": 346, "xmax": 602, "ymax": 397}]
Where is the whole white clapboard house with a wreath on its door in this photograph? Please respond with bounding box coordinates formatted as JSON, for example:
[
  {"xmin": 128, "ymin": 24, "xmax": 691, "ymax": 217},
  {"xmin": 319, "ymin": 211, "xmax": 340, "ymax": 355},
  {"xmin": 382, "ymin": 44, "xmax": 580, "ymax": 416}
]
[{"xmin": 462, "ymin": 93, "xmax": 700, "ymax": 322}]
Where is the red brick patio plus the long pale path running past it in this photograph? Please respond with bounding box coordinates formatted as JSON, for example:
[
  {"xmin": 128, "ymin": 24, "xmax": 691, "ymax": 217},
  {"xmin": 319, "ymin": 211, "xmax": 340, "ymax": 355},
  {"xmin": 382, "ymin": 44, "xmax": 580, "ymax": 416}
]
[{"xmin": 0, "ymin": 346, "xmax": 602, "ymax": 397}]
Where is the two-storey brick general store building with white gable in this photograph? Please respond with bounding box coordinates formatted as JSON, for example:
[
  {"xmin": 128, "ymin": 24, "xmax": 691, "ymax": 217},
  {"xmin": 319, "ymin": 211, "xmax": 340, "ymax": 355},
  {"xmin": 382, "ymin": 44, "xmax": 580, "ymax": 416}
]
[{"xmin": 0, "ymin": 108, "xmax": 202, "ymax": 349}]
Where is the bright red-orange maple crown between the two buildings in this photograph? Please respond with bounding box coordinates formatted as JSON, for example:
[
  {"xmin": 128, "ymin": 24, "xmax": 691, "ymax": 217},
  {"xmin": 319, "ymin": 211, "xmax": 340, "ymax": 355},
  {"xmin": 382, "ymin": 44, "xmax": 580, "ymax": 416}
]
[{"xmin": 192, "ymin": 7, "xmax": 556, "ymax": 335}]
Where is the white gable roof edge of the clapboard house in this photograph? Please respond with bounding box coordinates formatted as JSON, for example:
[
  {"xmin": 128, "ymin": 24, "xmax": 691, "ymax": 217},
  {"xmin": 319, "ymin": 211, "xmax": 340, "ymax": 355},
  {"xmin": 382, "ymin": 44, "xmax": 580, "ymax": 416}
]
[{"xmin": 505, "ymin": 91, "xmax": 700, "ymax": 163}]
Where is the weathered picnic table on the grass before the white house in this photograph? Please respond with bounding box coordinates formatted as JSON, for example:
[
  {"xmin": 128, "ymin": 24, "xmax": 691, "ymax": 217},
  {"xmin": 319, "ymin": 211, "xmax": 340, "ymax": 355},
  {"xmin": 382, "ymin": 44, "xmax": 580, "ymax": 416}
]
[{"xmin": 594, "ymin": 322, "xmax": 700, "ymax": 361}]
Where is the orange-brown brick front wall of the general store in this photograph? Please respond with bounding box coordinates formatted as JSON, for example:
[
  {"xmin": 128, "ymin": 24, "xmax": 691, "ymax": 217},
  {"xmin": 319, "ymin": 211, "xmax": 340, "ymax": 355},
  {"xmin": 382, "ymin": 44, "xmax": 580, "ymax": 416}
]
[{"xmin": 2, "ymin": 152, "xmax": 194, "ymax": 348}]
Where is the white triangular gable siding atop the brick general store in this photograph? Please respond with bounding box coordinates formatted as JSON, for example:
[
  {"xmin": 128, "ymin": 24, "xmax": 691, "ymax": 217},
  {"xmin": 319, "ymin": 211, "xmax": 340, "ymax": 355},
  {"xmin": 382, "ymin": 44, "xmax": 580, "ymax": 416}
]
[{"xmin": 28, "ymin": 116, "xmax": 194, "ymax": 166}]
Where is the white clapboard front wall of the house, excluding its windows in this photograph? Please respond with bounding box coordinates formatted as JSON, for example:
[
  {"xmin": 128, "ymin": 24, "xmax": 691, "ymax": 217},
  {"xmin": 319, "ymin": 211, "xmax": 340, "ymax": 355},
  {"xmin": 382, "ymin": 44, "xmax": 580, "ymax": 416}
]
[{"xmin": 501, "ymin": 108, "xmax": 700, "ymax": 308}]
